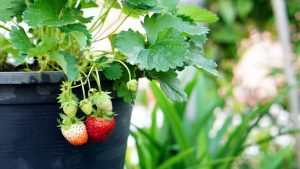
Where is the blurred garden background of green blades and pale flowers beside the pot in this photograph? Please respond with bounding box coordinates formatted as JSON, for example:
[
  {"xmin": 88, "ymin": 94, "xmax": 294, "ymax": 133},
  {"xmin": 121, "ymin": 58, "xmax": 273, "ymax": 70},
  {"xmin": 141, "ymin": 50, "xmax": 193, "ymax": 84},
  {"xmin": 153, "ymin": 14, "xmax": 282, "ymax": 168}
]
[{"xmin": 126, "ymin": 0, "xmax": 300, "ymax": 169}]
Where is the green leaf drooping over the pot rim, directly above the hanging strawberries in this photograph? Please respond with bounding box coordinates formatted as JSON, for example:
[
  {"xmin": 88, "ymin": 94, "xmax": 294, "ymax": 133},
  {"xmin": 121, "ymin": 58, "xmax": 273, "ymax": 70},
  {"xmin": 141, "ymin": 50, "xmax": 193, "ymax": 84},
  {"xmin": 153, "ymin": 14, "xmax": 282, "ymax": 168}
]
[{"xmin": 50, "ymin": 51, "xmax": 79, "ymax": 80}]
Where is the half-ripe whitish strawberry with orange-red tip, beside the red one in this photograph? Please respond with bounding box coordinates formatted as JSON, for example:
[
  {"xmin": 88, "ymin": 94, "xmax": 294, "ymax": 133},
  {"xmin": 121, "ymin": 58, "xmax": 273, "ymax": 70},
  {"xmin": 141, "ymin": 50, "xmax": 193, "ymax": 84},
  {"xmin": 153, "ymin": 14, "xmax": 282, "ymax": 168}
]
[{"xmin": 60, "ymin": 114, "xmax": 88, "ymax": 146}]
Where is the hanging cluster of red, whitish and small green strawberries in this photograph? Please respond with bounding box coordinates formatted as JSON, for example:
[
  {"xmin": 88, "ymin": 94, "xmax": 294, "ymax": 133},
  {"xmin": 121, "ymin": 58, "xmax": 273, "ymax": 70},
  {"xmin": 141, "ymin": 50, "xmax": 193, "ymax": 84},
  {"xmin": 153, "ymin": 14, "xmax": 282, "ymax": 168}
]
[{"xmin": 58, "ymin": 82, "xmax": 119, "ymax": 146}]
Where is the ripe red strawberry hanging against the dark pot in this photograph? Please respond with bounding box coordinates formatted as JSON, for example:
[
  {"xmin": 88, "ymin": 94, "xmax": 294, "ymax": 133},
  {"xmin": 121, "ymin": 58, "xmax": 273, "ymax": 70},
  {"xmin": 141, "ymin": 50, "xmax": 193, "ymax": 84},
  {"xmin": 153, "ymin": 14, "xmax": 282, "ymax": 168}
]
[{"xmin": 86, "ymin": 116, "xmax": 115, "ymax": 143}]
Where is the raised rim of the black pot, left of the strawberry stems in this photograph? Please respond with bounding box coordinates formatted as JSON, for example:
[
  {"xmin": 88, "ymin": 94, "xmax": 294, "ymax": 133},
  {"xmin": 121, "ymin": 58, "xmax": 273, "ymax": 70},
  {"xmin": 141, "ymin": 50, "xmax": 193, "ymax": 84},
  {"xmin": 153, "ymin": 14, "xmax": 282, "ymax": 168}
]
[{"xmin": 0, "ymin": 71, "xmax": 67, "ymax": 85}]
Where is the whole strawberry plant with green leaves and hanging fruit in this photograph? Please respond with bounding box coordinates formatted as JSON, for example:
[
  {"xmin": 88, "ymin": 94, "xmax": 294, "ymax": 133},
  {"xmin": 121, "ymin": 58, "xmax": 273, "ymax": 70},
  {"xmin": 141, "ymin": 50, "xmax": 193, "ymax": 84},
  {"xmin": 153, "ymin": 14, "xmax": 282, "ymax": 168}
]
[{"xmin": 0, "ymin": 0, "xmax": 218, "ymax": 145}]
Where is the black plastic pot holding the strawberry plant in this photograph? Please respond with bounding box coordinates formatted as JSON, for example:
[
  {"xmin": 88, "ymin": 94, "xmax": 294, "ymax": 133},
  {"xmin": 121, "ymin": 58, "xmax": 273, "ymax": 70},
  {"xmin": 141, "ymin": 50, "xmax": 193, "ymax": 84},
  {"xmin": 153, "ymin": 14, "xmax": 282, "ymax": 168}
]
[{"xmin": 0, "ymin": 72, "xmax": 132, "ymax": 169}]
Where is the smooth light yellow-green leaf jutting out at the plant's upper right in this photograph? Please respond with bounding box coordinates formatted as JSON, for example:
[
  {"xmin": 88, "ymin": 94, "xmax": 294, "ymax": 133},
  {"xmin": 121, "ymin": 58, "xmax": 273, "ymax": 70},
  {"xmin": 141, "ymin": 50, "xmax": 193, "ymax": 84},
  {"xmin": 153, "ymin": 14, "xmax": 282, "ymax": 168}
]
[{"xmin": 177, "ymin": 5, "xmax": 219, "ymax": 23}]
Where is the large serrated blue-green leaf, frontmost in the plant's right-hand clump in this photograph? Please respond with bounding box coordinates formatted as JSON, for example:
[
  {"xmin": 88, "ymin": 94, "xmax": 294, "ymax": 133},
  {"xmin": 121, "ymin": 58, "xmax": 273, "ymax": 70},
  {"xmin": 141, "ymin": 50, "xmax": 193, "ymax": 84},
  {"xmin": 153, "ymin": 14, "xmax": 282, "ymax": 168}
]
[{"xmin": 136, "ymin": 28, "xmax": 189, "ymax": 72}]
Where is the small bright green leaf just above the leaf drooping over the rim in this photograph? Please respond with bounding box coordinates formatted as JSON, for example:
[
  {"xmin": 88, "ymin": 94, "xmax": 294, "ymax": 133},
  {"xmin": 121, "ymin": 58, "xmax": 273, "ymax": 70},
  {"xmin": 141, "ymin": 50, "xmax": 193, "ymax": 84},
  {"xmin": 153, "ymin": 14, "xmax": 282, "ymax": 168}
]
[{"xmin": 27, "ymin": 36, "xmax": 59, "ymax": 56}]
